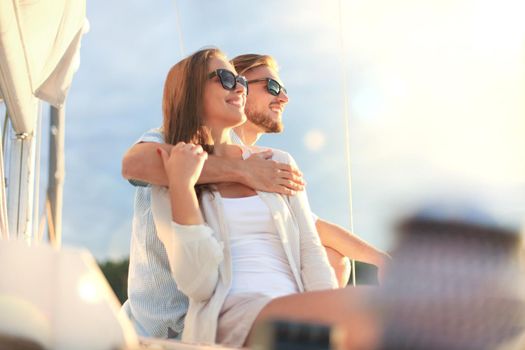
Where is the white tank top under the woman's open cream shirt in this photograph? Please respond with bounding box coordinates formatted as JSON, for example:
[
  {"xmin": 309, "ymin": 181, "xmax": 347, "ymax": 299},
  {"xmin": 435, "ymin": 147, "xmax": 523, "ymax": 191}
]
[{"xmin": 222, "ymin": 195, "xmax": 299, "ymax": 297}]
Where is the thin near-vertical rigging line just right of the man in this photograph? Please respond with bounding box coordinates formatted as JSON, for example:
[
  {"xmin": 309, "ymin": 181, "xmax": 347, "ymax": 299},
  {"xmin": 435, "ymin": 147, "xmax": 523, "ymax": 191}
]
[{"xmin": 338, "ymin": 0, "xmax": 356, "ymax": 287}]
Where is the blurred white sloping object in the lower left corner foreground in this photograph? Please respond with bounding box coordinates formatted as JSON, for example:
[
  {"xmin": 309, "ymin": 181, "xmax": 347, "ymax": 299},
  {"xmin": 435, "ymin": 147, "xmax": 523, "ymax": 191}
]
[{"xmin": 0, "ymin": 240, "xmax": 138, "ymax": 350}]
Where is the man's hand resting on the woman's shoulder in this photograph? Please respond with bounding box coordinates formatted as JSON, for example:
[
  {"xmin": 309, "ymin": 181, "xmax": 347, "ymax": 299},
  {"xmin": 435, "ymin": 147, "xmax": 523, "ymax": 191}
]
[{"xmin": 236, "ymin": 150, "xmax": 305, "ymax": 195}]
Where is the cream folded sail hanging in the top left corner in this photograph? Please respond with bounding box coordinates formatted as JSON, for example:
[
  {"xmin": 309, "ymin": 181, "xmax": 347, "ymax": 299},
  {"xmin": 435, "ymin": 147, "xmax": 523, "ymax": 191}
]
[{"xmin": 0, "ymin": 0, "xmax": 88, "ymax": 133}]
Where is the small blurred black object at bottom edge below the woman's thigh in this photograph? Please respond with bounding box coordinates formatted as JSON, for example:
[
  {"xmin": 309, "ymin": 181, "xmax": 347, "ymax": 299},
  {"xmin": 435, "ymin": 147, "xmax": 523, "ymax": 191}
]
[{"xmin": 249, "ymin": 320, "xmax": 330, "ymax": 350}]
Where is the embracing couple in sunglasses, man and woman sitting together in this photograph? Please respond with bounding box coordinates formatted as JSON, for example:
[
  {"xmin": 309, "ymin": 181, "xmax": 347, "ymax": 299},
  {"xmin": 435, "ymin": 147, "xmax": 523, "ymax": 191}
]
[{"xmin": 123, "ymin": 49, "xmax": 384, "ymax": 347}]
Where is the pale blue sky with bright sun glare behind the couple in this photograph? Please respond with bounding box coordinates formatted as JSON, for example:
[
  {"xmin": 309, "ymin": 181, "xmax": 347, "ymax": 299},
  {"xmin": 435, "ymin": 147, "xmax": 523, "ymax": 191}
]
[{"xmin": 9, "ymin": 0, "xmax": 525, "ymax": 260}]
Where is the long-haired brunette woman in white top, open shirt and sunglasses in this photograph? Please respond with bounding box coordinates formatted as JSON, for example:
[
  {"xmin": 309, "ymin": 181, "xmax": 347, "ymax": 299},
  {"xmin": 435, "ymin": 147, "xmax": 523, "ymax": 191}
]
[{"xmin": 152, "ymin": 49, "xmax": 368, "ymax": 346}]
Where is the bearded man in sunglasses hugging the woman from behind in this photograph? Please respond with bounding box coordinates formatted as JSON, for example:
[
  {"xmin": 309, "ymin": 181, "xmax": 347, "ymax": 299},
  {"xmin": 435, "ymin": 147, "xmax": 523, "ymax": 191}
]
[{"xmin": 122, "ymin": 55, "xmax": 385, "ymax": 338}]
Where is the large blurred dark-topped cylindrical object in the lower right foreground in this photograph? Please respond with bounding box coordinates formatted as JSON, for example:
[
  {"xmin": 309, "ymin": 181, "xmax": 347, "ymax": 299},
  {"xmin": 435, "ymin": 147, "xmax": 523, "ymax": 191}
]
[{"xmin": 379, "ymin": 215, "xmax": 525, "ymax": 350}]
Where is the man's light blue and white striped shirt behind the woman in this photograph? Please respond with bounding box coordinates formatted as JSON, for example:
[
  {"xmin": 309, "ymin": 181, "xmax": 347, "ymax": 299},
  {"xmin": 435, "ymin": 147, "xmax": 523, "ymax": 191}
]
[{"xmin": 122, "ymin": 129, "xmax": 188, "ymax": 339}]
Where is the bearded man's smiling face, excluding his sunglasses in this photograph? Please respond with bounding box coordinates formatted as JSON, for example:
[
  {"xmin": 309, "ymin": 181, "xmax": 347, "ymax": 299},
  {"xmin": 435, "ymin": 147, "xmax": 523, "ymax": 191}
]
[{"xmin": 244, "ymin": 66, "xmax": 288, "ymax": 133}]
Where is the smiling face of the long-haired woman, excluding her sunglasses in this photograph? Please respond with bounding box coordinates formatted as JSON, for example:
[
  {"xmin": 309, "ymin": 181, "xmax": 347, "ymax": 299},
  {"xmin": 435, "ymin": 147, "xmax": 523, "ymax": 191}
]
[{"xmin": 204, "ymin": 57, "xmax": 246, "ymax": 129}]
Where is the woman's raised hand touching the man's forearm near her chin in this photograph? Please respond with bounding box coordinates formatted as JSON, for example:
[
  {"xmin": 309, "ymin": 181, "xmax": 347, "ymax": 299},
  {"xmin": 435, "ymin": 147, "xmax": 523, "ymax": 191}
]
[{"xmin": 157, "ymin": 142, "xmax": 208, "ymax": 188}]
